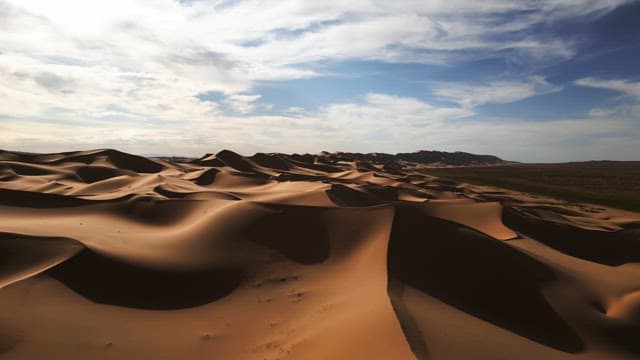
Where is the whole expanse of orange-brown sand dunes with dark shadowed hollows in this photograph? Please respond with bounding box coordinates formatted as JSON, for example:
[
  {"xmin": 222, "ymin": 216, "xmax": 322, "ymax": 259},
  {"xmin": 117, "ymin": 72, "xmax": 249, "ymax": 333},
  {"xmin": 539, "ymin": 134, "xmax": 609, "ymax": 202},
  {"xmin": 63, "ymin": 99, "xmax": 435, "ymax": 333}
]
[{"xmin": 0, "ymin": 150, "xmax": 640, "ymax": 359}]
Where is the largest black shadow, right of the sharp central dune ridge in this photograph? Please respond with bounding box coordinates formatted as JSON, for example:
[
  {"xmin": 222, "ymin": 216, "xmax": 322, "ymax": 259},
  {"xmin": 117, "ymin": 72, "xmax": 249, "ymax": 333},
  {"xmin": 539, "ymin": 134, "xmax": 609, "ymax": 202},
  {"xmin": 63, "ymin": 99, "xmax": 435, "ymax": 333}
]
[{"xmin": 388, "ymin": 206, "xmax": 585, "ymax": 353}]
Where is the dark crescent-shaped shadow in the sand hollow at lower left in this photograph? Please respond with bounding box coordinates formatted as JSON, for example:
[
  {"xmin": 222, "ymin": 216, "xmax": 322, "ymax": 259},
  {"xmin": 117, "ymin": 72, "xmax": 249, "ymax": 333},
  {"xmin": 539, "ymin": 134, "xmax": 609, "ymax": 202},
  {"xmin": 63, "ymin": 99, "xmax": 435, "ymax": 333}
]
[{"xmin": 47, "ymin": 250, "xmax": 242, "ymax": 310}]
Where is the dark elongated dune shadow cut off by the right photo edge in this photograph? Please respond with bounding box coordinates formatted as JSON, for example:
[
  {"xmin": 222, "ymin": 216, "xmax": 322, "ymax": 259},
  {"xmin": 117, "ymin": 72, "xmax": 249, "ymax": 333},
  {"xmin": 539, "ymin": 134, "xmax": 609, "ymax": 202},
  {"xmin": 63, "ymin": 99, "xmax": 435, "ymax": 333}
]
[{"xmin": 502, "ymin": 207, "xmax": 640, "ymax": 266}]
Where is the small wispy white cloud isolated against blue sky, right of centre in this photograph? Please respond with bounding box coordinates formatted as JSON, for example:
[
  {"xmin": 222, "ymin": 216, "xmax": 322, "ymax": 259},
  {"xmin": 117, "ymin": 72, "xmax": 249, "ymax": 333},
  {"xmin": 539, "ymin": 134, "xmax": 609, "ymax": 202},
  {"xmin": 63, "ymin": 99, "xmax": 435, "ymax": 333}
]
[{"xmin": 434, "ymin": 76, "xmax": 562, "ymax": 108}]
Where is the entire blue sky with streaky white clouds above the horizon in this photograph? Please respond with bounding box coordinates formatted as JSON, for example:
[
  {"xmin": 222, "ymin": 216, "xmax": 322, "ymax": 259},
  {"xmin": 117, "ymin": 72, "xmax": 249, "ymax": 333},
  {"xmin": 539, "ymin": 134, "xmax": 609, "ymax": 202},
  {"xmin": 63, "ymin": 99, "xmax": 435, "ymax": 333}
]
[{"xmin": 0, "ymin": 0, "xmax": 640, "ymax": 162}]
